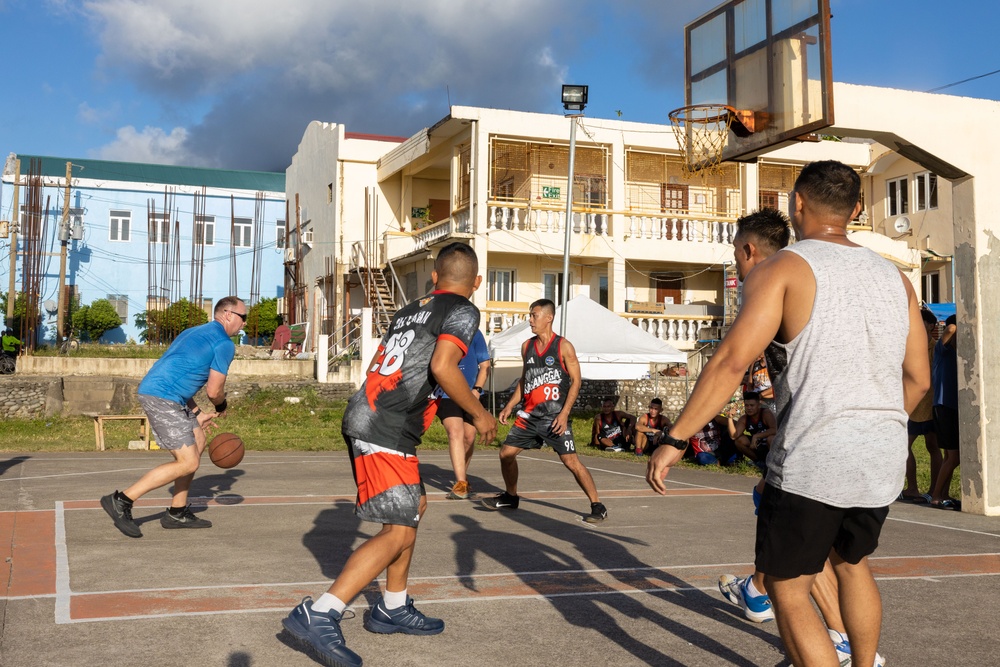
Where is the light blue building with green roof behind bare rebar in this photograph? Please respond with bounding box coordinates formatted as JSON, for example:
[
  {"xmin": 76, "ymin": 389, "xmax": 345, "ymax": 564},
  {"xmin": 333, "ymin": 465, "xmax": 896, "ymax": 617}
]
[{"xmin": 0, "ymin": 155, "xmax": 287, "ymax": 342}]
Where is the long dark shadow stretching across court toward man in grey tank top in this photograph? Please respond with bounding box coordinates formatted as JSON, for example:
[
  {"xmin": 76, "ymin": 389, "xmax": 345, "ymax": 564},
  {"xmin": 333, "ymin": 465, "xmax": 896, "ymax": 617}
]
[{"xmin": 451, "ymin": 500, "xmax": 780, "ymax": 667}]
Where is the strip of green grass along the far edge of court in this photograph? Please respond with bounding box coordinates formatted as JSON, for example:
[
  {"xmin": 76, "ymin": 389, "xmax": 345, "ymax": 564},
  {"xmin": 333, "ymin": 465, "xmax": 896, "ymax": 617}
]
[{"xmin": 0, "ymin": 390, "xmax": 961, "ymax": 498}]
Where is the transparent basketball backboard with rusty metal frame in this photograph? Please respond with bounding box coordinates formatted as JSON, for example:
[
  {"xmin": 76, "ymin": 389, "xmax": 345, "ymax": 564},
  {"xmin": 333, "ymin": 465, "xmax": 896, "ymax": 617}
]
[{"xmin": 684, "ymin": 0, "xmax": 833, "ymax": 166}]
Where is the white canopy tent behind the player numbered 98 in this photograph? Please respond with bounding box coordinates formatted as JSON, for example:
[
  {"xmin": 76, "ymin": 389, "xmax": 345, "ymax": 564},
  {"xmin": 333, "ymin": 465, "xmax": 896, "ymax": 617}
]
[{"xmin": 489, "ymin": 294, "xmax": 687, "ymax": 380}]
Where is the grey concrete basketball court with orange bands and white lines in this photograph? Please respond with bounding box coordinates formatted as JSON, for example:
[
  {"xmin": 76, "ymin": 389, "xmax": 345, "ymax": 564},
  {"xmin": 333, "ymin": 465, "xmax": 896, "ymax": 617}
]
[{"xmin": 0, "ymin": 450, "xmax": 1000, "ymax": 667}]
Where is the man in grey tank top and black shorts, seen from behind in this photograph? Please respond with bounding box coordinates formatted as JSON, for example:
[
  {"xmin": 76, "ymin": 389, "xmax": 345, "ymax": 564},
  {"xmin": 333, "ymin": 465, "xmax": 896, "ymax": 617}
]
[{"xmin": 646, "ymin": 161, "xmax": 930, "ymax": 667}]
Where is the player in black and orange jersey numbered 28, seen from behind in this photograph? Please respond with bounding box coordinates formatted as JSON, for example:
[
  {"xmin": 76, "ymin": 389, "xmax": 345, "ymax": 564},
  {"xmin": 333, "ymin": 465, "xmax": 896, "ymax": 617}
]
[{"xmin": 282, "ymin": 243, "xmax": 496, "ymax": 667}]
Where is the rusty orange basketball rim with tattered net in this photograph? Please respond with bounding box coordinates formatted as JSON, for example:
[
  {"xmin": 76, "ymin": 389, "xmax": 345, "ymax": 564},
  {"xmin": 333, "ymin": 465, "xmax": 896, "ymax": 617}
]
[{"xmin": 670, "ymin": 104, "xmax": 753, "ymax": 179}]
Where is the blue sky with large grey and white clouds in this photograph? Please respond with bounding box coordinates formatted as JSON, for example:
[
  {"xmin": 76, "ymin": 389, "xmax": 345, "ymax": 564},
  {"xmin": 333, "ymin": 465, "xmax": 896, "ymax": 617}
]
[{"xmin": 0, "ymin": 0, "xmax": 1000, "ymax": 171}]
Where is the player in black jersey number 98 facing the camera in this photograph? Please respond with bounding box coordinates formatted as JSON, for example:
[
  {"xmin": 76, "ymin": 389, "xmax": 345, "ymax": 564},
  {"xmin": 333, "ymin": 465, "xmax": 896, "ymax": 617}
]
[{"xmin": 483, "ymin": 299, "xmax": 608, "ymax": 523}]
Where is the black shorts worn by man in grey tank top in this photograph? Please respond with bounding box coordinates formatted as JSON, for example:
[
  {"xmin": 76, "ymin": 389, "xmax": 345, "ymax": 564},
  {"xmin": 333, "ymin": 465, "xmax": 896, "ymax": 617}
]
[{"xmin": 754, "ymin": 484, "xmax": 889, "ymax": 579}]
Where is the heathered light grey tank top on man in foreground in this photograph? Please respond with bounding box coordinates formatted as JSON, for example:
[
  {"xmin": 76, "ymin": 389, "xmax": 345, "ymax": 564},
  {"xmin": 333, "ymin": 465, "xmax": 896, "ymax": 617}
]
[{"xmin": 767, "ymin": 240, "xmax": 909, "ymax": 507}]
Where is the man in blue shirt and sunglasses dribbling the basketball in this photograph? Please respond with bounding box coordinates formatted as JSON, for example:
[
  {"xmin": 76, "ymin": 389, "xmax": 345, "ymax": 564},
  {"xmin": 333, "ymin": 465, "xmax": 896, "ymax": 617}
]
[{"xmin": 101, "ymin": 296, "xmax": 247, "ymax": 537}]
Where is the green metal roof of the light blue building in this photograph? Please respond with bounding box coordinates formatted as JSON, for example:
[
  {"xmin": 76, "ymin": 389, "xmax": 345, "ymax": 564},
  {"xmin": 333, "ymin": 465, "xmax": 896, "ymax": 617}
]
[{"xmin": 17, "ymin": 155, "xmax": 285, "ymax": 193}]
